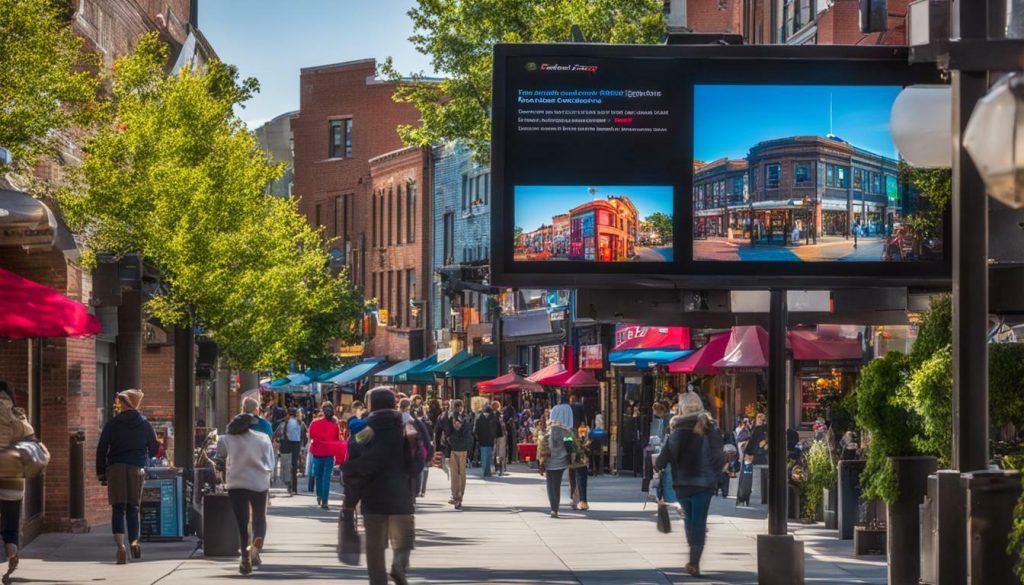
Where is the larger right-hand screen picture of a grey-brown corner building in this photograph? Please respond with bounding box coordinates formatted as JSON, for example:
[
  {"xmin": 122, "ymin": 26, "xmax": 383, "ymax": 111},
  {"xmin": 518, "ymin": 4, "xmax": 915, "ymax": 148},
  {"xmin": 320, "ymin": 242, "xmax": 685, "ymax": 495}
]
[{"xmin": 692, "ymin": 85, "xmax": 943, "ymax": 262}]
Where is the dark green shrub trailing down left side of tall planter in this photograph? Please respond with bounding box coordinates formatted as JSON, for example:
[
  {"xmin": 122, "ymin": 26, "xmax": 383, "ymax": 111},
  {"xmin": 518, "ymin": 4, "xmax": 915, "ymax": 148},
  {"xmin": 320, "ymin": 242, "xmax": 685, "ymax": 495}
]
[{"xmin": 855, "ymin": 351, "xmax": 921, "ymax": 503}]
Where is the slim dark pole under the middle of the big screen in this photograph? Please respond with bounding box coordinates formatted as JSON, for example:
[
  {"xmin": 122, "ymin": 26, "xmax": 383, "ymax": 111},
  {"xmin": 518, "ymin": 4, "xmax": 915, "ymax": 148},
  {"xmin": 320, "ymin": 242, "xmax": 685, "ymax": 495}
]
[{"xmin": 768, "ymin": 289, "xmax": 788, "ymax": 536}]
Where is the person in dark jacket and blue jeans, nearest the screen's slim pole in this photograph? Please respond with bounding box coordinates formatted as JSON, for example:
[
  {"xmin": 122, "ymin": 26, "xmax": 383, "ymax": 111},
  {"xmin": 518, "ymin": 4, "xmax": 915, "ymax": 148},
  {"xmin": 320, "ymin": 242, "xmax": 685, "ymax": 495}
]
[{"xmin": 654, "ymin": 393, "xmax": 725, "ymax": 577}]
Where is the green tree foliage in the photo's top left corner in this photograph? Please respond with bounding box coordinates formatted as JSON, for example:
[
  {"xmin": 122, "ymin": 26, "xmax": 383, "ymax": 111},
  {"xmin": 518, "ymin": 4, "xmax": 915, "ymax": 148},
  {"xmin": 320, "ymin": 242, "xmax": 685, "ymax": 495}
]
[{"xmin": 0, "ymin": 0, "xmax": 98, "ymax": 166}]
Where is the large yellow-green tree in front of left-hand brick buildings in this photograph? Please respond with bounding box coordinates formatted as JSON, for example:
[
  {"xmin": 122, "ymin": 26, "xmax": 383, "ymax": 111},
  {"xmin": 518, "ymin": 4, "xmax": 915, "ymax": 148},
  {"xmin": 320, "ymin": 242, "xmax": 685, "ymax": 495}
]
[{"xmin": 60, "ymin": 34, "xmax": 362, "ymax": 371}]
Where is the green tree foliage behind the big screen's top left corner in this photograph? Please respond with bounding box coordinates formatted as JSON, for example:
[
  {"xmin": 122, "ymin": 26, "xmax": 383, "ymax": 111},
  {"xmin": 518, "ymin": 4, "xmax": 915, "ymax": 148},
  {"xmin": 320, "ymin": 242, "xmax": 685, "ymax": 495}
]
[{"xmin": 382, "ymin": 0, "xmax": 666, "ymax": 161}]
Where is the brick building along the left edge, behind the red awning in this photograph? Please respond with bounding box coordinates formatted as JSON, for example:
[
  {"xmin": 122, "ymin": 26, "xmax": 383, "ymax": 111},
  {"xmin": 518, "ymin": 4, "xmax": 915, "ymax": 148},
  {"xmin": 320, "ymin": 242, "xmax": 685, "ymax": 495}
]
[{"xmin": 0, "ymin": 0, "xmax": 213, "ymax": 539}]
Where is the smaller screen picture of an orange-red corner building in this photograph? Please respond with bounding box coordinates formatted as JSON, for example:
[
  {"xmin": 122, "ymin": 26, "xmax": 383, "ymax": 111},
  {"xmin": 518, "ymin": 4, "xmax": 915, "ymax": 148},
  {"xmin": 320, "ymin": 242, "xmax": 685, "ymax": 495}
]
[{"xmin": 513, "ymin": 185, "xmax": 673, "ymax": 262}]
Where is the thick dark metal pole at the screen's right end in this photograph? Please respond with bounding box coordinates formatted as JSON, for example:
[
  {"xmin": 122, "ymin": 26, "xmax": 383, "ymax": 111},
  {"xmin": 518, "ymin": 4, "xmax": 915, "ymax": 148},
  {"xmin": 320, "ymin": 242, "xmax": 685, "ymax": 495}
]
[{"xmin": 952, "ymin": 0, "xmax": 988, "ymax": 471}]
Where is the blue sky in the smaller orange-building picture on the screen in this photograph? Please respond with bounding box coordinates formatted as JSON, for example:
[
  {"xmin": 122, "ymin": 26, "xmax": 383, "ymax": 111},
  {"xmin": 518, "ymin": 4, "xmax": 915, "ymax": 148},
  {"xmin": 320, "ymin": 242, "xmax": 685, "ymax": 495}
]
[{"xmin": 515, "ymin": 184, "xmax": 672, "ymax": 232}]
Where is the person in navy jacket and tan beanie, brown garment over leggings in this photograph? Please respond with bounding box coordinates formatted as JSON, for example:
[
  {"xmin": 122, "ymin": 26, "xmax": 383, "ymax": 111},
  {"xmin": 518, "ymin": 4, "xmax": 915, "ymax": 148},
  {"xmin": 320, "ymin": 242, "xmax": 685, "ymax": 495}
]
[{"xmin": 96, "ymin": 389, "xmax": 160, "ymax": 565}]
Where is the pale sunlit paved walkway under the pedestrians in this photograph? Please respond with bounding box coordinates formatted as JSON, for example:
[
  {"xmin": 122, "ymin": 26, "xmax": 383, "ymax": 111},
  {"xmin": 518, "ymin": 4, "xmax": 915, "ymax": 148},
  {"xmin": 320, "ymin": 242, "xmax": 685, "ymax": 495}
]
[{"xmin": 14, "ymin": 466, "xmax": 886, "ymax": 585}]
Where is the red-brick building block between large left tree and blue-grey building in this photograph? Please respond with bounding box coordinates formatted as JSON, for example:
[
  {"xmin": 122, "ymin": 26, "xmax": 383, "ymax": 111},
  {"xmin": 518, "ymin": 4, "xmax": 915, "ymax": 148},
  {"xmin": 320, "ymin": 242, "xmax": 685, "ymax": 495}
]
[{"xmin": 291, "ymin": 58, "xmax": 430, "ymax": 360}]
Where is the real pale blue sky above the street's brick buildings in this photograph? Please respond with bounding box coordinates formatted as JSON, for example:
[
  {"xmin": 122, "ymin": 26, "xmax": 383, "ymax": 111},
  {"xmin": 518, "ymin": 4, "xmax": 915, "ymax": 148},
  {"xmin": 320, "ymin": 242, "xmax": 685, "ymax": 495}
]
[{"xmin": 199, "ymin": 0, "xmax": 433, "ymax": 128}]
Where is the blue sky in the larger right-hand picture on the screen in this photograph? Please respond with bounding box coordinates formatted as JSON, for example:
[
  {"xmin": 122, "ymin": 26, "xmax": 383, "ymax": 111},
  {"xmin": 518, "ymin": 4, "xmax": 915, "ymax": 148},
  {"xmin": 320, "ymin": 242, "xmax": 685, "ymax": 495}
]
[{"xmin": 693, "ymin": 85, "xmax": 901, "ymax": 162}]
